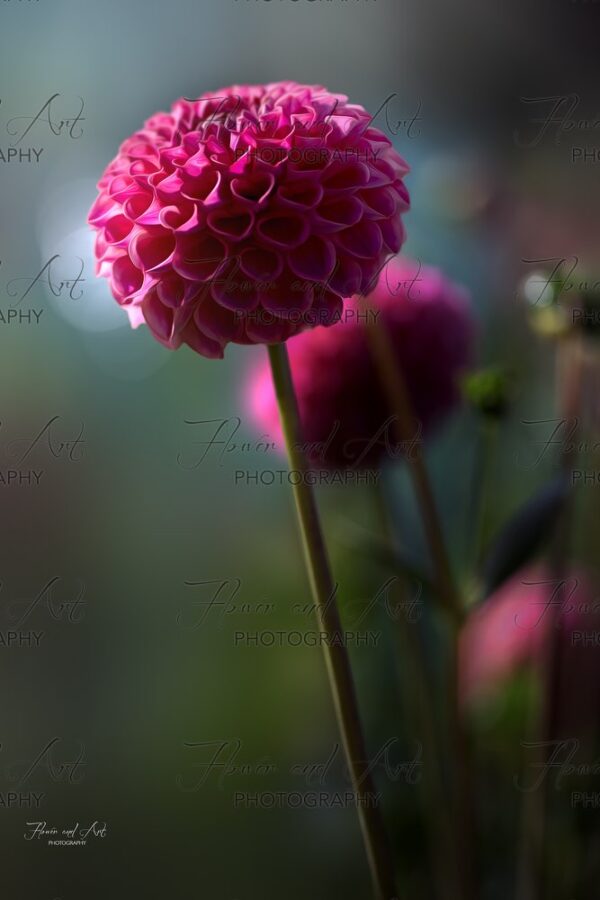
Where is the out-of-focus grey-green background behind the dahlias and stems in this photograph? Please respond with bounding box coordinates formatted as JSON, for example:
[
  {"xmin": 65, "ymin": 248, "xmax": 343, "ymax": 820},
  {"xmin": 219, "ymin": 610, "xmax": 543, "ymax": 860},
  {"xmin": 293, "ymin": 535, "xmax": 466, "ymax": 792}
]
[{"xmin": 0, "ymin": 0, "xmax": 600, "ymax": 900}]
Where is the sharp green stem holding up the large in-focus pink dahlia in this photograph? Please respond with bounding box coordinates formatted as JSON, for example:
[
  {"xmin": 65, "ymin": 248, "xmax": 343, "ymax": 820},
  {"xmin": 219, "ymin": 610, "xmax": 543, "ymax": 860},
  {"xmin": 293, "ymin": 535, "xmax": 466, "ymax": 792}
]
[{"xmin": 268, "ymin": 344, "xmax": 398, "ymax": 900}]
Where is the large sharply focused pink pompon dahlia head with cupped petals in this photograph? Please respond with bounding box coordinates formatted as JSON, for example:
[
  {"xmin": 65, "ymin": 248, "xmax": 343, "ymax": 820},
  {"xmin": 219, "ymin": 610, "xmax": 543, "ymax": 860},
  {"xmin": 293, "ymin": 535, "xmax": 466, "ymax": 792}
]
[{"xmin": 89, "ymin": 82, "xmax": 409, "ymax": 358}]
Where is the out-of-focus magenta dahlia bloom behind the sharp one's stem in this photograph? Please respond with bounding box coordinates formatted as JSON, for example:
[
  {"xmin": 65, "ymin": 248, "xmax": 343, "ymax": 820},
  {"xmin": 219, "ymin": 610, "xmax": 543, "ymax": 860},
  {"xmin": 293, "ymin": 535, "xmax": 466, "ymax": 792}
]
[{"xmin": 244, "ymin": 253, "xmax": 474, "ymax": 468}]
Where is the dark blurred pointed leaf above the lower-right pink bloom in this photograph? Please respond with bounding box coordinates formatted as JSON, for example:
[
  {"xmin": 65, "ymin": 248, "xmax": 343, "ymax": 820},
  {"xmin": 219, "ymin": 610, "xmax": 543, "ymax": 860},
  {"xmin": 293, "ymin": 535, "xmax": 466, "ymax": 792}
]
[{"xmin": 482, "ymin": 473, "xmax": 568, "ymax": 599}]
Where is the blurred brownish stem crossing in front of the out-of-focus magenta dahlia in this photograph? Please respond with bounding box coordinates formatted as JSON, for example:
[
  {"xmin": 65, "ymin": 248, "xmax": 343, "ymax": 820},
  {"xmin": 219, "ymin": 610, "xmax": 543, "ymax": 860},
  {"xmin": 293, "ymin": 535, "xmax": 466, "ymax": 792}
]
[{"xmin": 366, "ymin": 301, "xmax": 475, "ymax": 900}]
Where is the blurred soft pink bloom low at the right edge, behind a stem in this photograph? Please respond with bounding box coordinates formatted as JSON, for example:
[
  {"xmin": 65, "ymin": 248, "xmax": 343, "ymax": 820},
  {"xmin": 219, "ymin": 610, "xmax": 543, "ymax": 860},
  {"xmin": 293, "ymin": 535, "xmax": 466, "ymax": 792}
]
[{"xmin": 460, "ymin": 565, "xmax": 600, "ymax": 727}]
